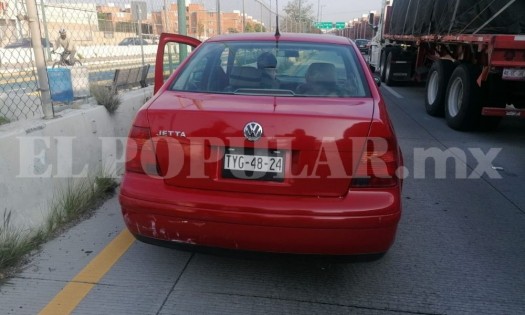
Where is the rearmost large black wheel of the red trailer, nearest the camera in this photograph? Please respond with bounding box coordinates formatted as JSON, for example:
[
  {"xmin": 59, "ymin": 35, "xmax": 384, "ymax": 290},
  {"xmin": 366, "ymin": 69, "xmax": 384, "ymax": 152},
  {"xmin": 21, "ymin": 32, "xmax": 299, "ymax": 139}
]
[{"xmin": 445, "ymin": 64, "xmax": 481, "ymax": 130}]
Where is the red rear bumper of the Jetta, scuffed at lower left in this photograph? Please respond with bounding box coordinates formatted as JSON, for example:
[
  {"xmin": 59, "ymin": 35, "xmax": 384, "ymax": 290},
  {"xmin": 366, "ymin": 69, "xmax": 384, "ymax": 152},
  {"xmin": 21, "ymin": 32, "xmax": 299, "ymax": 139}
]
[{"xmin": 119, "ymin": 174, "xmax": 401, "ymax": 255}]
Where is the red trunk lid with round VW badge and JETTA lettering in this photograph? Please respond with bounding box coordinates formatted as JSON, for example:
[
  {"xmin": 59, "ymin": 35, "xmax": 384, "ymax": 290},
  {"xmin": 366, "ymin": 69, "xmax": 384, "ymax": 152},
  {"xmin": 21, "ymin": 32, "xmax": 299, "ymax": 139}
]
[{"xmin": 148, "ymin": 92, "xmax": 374, "ymax": 197}]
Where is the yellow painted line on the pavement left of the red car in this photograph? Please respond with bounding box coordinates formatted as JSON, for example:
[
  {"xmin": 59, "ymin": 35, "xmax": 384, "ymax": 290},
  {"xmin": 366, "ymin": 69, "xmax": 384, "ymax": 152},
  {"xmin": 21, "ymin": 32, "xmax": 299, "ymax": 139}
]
[{"xmin": 39, "ymin": 229, "xmax": 135, "ymax": 315}]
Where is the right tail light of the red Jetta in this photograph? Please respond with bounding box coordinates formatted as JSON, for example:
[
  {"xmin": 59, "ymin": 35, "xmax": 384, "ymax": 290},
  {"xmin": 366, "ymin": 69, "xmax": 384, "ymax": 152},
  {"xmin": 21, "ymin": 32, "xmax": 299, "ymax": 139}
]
[{"xmin": 352, "ymin": 138, "xmax": 400, "ymax": 188}]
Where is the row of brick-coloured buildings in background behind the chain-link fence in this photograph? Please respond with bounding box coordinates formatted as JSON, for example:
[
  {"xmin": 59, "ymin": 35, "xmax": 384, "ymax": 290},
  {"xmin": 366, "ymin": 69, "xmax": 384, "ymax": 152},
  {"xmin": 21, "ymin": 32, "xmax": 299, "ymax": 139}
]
[{"xmin": 0, "ymin": 0, "xmax": 265, "ymax": 47}]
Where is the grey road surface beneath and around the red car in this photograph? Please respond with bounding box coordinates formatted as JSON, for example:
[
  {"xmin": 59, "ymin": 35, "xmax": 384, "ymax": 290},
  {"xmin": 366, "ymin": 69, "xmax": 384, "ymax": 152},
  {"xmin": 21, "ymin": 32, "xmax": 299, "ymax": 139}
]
[{"xmin": 0, "ymin": 82, "xmax": 525, "ymax": 315}]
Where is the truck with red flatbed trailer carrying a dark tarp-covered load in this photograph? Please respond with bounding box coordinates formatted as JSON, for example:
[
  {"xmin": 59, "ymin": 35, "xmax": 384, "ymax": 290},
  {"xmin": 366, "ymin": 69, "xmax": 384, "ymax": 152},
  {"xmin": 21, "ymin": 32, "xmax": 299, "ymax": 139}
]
[{"xmin": 369, "ymin": 0, "xmax": 525, "ymax": 130}]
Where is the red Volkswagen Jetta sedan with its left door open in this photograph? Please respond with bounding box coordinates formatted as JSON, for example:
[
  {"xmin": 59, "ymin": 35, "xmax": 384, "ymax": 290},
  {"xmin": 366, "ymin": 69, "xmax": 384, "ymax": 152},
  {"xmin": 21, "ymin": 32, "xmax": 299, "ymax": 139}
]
[{"xmin": 120, "ymin": 33, "xmax": 402, "ymax": 255}]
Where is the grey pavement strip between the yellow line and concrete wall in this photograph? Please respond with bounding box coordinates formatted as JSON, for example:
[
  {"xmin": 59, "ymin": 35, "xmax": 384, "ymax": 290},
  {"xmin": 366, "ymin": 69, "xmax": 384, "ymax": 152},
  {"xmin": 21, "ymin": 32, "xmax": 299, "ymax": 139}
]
[{"xmin": 0, "ymin": 194, "xmax": 125, "ymax": 315}]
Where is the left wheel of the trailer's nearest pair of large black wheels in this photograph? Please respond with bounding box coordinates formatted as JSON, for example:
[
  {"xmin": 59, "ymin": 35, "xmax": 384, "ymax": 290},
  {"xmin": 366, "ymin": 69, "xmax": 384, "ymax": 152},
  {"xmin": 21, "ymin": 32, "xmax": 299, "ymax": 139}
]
[{"xmin": 425, "ymin": 60, "xmax": 454, "ymax": 117}]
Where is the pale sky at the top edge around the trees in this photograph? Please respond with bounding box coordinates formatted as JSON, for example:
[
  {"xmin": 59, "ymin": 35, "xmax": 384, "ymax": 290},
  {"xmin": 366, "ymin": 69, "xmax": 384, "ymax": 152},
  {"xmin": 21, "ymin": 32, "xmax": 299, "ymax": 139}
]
[{"xmin": 191, "ymin": 0, "xmax": 382, "ymax": 22}]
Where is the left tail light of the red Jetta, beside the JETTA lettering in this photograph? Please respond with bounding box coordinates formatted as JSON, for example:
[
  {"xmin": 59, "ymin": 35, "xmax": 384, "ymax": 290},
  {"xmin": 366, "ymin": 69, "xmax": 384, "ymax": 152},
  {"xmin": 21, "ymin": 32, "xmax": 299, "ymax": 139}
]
[{"xmin": 126, "ymin": 111, "xmax": 158, "ymax": 175}]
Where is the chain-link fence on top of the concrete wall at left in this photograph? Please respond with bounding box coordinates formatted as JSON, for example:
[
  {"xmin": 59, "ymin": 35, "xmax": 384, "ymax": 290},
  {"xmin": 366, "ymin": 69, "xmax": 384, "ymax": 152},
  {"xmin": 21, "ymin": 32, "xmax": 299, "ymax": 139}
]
[{"xmin": 0, "ymin": 0, "xmax": 282, "ymax": 122}]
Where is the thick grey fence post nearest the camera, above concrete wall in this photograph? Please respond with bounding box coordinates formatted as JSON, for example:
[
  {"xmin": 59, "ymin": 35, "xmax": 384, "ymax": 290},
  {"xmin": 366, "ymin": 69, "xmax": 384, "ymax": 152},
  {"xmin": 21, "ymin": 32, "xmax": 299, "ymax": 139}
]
[{"xmin": 26, "ymin": 0, "xmax": 54, "ymax": 119}]
